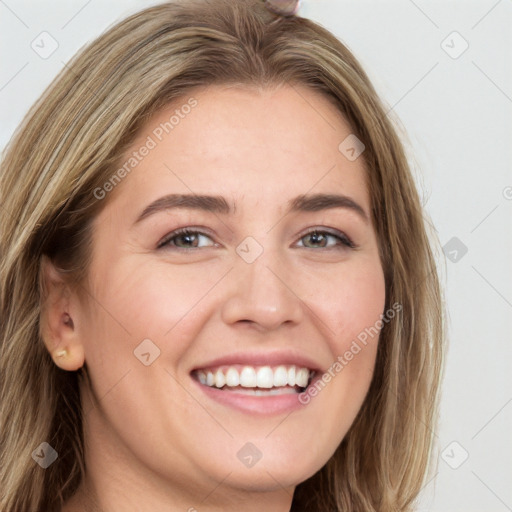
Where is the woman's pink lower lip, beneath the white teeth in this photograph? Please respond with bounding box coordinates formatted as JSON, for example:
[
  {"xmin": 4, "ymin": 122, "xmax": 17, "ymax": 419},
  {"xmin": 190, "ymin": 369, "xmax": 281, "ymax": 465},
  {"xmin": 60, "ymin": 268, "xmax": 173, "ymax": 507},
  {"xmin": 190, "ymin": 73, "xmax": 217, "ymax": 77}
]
[{"xmin": 192, "ymin": 378, "xmax": 314, "ymax": 416}]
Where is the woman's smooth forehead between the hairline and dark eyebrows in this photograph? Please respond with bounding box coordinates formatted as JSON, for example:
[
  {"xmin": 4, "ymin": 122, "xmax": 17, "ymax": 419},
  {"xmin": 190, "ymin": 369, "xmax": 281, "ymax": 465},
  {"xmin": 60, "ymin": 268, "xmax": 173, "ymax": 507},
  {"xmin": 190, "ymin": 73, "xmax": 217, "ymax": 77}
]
[{"xmin": 100, "ymin": 85, "xmax": 368, "ymax": 218}]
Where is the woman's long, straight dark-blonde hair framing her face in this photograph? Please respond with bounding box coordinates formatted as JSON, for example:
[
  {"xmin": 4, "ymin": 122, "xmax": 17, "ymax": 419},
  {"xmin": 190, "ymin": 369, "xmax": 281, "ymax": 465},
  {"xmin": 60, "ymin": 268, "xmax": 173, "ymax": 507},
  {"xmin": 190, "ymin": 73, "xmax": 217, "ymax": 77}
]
[{"xmin": 0, "ymin": 0, "xmax": 444, "ymax": 512}]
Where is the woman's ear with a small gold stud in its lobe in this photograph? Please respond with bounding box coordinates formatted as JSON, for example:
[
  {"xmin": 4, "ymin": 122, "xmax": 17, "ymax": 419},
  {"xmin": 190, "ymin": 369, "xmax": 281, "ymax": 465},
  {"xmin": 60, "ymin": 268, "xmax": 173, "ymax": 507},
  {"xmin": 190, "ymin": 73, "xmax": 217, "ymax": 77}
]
[{"xmin": 39, "ymin": 255, "xmax": 85, "ymax": 371}]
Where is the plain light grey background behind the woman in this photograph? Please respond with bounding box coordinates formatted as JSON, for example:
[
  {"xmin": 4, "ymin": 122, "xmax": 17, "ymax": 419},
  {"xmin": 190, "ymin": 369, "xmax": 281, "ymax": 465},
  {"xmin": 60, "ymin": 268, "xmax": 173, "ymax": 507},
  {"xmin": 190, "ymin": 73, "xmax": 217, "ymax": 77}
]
[{"xmin": 0, "ymin": 0, "xmax": 512, "ymax": 512}]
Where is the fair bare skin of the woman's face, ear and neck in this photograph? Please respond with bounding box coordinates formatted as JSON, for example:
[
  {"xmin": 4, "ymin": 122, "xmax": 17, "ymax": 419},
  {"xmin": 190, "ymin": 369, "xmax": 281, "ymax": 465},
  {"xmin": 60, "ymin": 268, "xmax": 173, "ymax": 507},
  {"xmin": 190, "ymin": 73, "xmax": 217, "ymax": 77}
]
[{"xmin": 45, "ymin": 85, "xmax": 385, "ymax": 512}]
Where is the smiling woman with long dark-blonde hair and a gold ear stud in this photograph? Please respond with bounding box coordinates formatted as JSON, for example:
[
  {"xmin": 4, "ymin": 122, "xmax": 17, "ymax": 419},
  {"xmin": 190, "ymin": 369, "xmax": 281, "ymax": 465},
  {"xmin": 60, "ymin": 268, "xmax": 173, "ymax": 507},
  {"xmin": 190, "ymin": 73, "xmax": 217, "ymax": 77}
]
[{"xmin": 0, "ymin": 0, "xmax": 443, "ymax": 512}]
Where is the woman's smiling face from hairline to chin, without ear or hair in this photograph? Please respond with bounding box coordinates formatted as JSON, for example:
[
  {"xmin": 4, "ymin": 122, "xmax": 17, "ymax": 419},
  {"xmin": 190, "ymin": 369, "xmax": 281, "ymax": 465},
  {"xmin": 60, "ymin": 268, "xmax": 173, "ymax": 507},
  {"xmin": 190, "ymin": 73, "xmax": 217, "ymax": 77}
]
[{"xmin": 67, "ymin": 86, "xmax": 385, "ymax": 508}]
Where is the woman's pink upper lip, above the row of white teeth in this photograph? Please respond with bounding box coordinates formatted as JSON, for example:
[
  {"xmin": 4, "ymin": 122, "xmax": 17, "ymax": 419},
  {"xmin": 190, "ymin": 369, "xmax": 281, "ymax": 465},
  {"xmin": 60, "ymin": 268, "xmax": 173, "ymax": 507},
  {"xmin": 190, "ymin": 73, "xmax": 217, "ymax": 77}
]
[{"xmin": 192, "ymin": 350, "xmax": 320, "ymax": 371}]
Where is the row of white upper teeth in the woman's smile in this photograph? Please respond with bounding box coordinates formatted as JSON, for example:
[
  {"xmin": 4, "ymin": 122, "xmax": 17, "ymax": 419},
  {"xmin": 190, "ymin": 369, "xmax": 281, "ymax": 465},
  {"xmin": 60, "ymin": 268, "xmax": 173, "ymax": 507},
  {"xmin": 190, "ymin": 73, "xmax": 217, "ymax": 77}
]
[{"xmin": 196, "ymin": 365, "xmax": 313, "ymax": 389}]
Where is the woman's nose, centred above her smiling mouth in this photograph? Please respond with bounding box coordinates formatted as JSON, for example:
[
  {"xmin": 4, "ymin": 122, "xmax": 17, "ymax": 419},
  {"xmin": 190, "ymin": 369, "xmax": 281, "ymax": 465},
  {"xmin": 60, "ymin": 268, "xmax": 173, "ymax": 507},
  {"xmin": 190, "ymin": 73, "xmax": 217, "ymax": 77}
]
[{"xmin": 222, "ymin": 244, "xmax": 305, "ymax": 331}]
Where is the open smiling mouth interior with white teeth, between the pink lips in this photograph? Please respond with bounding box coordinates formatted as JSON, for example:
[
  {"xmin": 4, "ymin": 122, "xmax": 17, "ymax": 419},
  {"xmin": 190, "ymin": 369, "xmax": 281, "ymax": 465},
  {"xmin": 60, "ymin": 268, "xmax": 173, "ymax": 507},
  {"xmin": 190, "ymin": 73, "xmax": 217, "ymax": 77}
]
[{"xmin": 191, "ymin": 364, "xmax": 316, "ymax": 396}]
